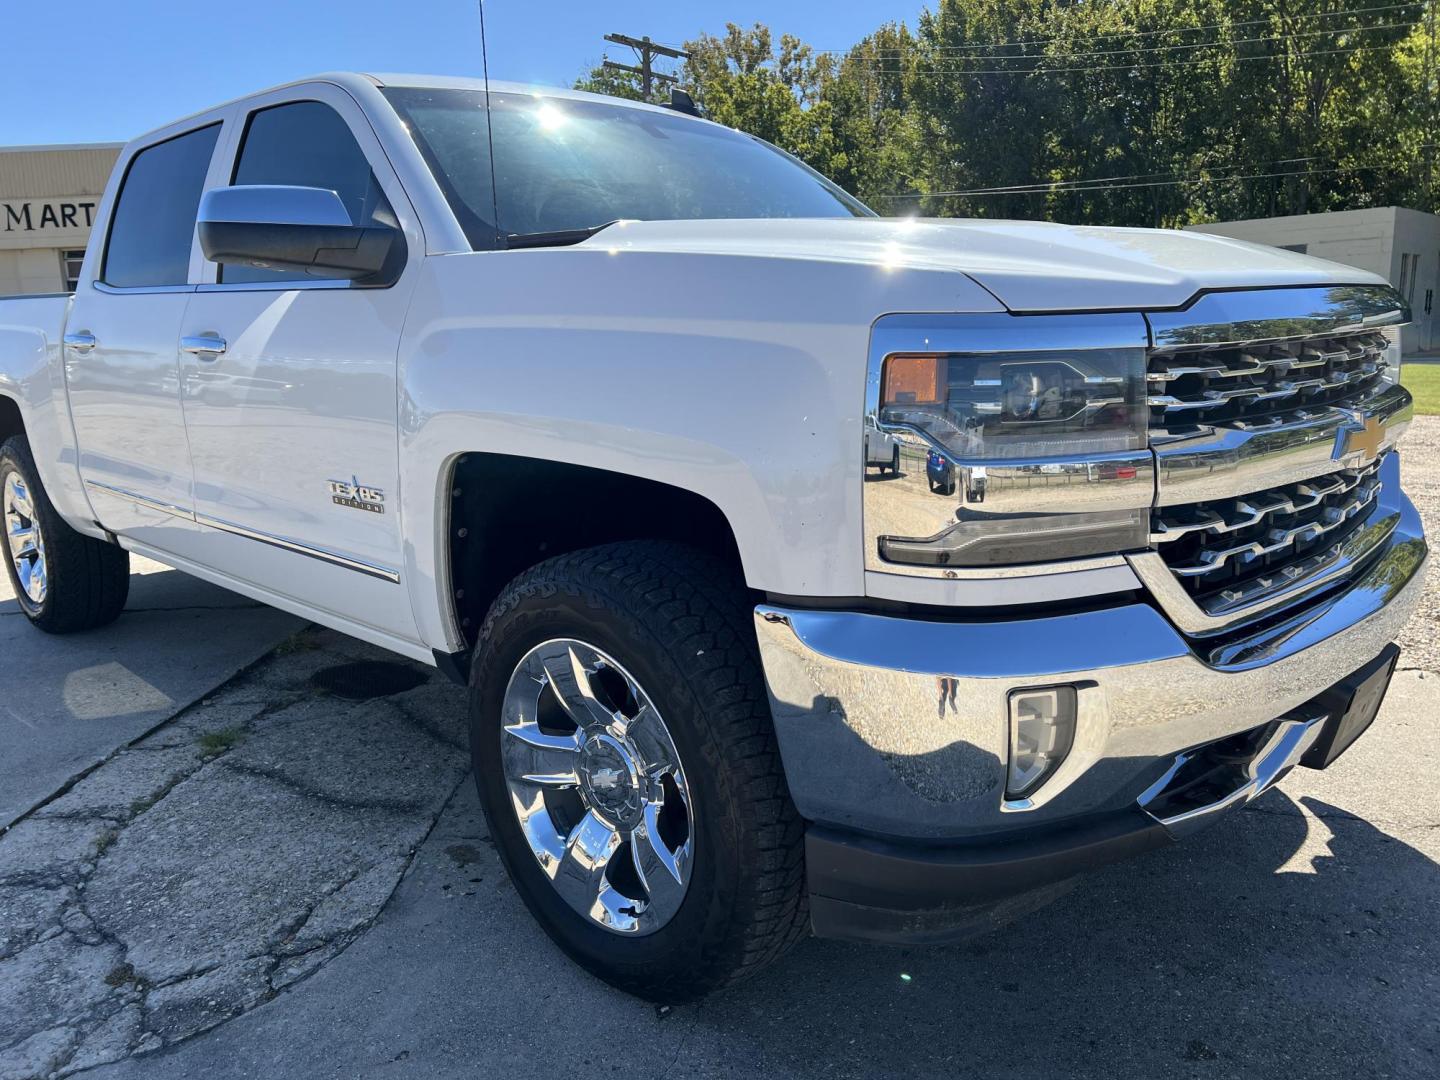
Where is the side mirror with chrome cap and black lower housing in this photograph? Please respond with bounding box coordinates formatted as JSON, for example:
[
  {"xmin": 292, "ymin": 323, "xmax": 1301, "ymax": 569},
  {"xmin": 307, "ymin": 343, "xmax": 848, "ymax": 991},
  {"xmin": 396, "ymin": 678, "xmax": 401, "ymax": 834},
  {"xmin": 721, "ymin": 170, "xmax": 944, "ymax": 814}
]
[{"xmin": 199, "ymin": 184, "xmax": 405, "ymax": 284}]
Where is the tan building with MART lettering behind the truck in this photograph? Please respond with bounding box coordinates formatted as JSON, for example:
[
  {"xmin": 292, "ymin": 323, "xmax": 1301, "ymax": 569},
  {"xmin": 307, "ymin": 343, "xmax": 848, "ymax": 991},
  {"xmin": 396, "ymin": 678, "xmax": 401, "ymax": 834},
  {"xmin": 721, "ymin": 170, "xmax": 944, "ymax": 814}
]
[{"xmin": 0, "ymin": 143, "xmax": 121, "ymax": 297}]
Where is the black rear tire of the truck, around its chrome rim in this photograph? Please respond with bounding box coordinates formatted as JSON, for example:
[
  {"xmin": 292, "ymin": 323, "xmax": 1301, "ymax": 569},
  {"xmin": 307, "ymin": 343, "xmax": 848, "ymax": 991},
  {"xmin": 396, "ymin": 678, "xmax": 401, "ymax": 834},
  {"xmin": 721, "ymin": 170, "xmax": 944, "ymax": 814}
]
[{"xmin": 0, "ymin": 435, "xmax": 130, "ymax": 634}]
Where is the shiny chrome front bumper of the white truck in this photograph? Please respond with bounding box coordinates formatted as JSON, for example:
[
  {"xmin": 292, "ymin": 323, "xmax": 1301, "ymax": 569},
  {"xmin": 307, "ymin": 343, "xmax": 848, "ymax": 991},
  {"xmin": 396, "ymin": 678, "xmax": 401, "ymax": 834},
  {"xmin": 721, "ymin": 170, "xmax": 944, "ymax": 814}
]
[{"xmin": 755, "ymin": 472, "xmax": 1427, "ymax": 842}]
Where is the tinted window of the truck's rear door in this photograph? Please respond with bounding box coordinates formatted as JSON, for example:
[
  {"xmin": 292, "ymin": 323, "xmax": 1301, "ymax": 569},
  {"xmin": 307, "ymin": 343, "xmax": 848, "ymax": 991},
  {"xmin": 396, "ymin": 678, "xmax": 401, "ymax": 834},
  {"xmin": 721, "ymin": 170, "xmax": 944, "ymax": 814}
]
[{"xmin": 101, "ymin": 124, "xmax": 220, "ymax": 288}]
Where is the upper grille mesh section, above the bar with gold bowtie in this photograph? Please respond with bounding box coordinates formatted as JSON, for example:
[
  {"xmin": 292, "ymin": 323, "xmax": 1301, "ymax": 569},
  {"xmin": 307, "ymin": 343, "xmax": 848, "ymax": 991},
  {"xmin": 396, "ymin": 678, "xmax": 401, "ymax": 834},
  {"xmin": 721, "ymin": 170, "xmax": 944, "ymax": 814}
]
[{"xmin": 1146, "ymin": 330, "xmax": 1390, "ymax": 433}]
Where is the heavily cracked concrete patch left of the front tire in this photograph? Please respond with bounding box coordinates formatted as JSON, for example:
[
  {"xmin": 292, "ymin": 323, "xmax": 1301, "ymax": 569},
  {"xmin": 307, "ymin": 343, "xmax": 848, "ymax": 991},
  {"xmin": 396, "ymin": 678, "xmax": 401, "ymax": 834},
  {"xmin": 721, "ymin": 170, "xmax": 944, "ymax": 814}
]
[{"xmin": 0, "ymin": 631, "xmax": 467, "ymax": 1080}]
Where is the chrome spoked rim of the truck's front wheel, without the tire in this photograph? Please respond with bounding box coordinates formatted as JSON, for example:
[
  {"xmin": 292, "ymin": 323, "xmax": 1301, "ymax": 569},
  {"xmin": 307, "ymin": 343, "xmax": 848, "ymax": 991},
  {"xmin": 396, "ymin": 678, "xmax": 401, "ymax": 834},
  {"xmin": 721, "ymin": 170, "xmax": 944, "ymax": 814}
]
[{"xmin": 500, "ymin": 638, "xmax": 696, "ymax": 936}]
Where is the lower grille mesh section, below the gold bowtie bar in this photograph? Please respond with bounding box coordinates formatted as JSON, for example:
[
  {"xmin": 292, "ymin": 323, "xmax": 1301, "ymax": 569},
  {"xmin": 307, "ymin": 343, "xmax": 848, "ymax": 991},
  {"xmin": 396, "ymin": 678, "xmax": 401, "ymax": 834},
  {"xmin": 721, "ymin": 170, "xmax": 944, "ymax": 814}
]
[{"xmin": 1151, "ymin": 458, "xmax": 1384, "ymax": 615}]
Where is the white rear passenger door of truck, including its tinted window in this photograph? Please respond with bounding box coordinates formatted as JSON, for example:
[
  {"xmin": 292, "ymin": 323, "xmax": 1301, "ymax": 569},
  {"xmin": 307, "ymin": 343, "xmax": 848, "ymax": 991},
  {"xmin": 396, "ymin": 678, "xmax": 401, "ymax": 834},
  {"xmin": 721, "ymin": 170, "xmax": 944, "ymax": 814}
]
[{"xmin": 65, "ymin": 124, "xmax": 220, "ymax": 550}]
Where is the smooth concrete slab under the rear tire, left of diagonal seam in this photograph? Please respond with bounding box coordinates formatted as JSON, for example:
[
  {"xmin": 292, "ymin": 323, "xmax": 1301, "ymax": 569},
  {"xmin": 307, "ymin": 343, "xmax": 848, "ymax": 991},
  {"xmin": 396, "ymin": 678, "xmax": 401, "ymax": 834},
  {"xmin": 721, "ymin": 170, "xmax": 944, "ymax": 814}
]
[{"xmin": 0, "ymin": 556, "xmax": 304, "ymax": 829}]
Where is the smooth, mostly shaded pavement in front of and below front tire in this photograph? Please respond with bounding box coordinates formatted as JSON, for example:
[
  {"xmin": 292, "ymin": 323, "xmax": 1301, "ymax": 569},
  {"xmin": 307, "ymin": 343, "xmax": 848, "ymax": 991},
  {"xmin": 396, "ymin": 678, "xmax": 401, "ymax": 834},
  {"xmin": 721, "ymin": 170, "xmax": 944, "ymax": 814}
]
[{"xmin": 86, "ymin": 671, "xmax": 1440, "ymax": 1080}]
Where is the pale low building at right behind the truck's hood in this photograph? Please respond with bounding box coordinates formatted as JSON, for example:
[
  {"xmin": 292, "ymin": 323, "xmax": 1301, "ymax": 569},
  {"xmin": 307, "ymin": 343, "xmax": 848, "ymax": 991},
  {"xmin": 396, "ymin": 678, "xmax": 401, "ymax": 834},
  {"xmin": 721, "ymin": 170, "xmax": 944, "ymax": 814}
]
[{"xmin": 1187, "ymin": 206, "xmax": 1440, "ymax": 360}]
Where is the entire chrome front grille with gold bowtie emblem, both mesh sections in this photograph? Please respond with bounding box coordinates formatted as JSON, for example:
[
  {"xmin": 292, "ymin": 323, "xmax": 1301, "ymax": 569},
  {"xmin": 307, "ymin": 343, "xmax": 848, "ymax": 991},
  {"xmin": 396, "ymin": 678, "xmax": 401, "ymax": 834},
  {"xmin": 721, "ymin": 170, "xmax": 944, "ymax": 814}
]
[{"xmin": 1128, "ymin": 284, "xmax": 1414, "ymax": 639}]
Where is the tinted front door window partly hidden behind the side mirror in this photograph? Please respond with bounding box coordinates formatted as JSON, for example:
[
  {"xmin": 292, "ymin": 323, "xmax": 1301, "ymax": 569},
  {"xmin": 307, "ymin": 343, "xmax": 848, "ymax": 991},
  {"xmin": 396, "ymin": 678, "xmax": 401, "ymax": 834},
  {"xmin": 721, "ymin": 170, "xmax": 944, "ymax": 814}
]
[{"xmin": 220, "ymin": 101, "xmax": 395, "ymax": 284}]
